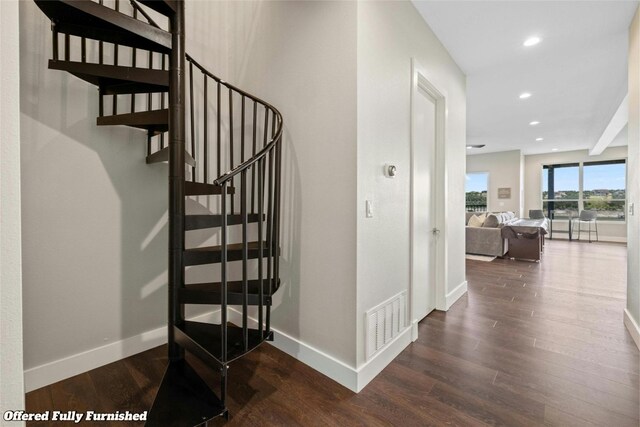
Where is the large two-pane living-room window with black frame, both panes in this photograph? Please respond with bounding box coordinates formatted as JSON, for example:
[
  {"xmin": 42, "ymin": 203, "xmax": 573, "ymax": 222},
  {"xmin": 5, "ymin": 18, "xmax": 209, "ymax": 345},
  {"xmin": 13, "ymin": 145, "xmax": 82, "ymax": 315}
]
[{"xmin": 542, "ymin": 160, "xmax": 626, "ymax": 221}]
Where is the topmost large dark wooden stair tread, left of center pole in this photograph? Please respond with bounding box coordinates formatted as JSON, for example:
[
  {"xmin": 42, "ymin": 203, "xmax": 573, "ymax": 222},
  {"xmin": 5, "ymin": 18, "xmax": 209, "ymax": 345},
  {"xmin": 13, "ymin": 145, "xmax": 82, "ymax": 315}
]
[{"xmin": 35, "ymin": 0, "xmax": 171, "ymax": 53}]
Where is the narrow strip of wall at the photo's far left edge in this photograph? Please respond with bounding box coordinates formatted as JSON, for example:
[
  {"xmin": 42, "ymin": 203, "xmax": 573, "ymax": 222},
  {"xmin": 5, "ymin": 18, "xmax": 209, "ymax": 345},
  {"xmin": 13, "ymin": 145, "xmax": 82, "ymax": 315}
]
[{"xmin": 0, "ymin": 1, "xmax": 24, "ymax": 416}]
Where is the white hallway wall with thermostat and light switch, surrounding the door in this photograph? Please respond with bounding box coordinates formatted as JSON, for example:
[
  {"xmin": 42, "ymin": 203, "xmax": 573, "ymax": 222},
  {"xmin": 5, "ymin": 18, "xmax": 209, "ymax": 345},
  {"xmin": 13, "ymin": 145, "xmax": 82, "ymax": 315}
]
[{"xmin": 356, "ymin": 2, "xmax": 466, "ymax": 367}]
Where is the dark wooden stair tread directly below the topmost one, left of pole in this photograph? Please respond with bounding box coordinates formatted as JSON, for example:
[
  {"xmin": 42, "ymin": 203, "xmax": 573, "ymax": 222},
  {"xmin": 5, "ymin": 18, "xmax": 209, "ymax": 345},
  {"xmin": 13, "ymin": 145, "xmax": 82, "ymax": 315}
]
[{"xmin": 49, "ymin": 59, "xmax": 169, "ymax": 94}]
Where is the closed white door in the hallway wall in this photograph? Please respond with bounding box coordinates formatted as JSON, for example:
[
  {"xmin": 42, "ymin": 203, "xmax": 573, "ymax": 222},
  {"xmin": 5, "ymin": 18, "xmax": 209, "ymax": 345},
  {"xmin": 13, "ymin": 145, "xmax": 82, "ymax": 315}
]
[{"xmin": 412, "ymin": 83, "xmax": 437, "ymax": 322}]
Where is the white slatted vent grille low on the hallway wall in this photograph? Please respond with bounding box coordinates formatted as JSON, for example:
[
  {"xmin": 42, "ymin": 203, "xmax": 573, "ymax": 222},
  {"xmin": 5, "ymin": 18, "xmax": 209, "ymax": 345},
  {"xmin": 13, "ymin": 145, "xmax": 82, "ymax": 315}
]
[{"xmin": 365, "ymin": 291, "xmax": 407, "ymax": 360}]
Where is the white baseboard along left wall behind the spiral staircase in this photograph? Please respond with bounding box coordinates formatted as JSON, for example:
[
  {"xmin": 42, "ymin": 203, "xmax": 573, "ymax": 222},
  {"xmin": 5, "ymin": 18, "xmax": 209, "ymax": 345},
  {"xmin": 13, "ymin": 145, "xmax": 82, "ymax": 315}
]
[{"xmin": 24, "ymin": 310, "xmax": 220, "ymax": 392}]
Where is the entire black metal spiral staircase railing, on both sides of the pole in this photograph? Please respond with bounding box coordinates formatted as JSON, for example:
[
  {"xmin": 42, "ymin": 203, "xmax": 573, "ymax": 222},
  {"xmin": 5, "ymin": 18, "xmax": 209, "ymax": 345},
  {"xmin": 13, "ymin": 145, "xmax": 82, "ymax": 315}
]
[{"xmin": 47, "ymin": 0, "xmax": 283, "ymax": 408}]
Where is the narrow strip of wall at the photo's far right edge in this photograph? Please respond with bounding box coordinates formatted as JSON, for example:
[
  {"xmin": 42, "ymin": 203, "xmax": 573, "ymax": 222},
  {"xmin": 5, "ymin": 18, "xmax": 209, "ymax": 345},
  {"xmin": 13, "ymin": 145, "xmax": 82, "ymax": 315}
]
[{"xmin": 625, "ymin": 6, "xmax": 640, "ymax": 347}]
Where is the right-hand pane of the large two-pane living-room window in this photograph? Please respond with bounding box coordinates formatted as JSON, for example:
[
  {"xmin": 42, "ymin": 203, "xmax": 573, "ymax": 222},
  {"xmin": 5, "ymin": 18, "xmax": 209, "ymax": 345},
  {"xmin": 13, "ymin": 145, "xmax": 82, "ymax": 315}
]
[{"xmin": 582, "ymin": 160, "xmax": 626, "ymax": 221}]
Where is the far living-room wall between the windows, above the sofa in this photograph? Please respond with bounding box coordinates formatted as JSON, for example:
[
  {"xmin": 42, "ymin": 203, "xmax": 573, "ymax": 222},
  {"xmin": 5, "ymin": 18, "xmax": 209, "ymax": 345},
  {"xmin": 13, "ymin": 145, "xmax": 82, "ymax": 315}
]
[{"xmin": 463, "ymin": 150, "xmax": 526, "ymax": 216}]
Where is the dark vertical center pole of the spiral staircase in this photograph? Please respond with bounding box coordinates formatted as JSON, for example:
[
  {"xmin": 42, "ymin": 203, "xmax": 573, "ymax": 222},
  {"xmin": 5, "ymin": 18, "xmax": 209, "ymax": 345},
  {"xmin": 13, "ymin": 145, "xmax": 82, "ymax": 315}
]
[{"xmin": 168, "ymin": 0, "xmax": 186, "ymax": 361}]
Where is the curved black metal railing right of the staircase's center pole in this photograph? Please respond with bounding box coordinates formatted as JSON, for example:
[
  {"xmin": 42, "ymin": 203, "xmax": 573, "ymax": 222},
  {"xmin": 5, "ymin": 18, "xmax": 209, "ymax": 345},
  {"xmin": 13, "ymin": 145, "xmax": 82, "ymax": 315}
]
[{"xmin": 186, "ymin": 55, "xmax": 282, "ymax": 362}]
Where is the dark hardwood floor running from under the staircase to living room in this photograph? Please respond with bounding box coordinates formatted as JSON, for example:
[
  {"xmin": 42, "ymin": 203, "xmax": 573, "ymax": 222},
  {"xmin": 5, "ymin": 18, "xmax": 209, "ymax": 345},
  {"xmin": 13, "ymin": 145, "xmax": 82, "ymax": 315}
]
[{"xmin": 27, "ymin": 241, "xmax": 640, "ymax": 427}]
